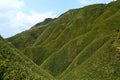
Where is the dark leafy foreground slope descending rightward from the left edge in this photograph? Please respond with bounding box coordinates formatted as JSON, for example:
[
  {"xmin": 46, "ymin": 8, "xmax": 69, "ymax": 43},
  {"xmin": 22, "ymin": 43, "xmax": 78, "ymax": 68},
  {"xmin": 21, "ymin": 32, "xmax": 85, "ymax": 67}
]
[{"xmin": 0, "ymin": 37, "xmax": 54, "ymax": 80}]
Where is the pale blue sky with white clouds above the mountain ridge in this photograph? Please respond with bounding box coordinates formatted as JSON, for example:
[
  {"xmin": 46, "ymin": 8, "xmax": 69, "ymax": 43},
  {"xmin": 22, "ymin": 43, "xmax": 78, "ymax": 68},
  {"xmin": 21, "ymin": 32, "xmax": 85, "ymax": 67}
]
[{"xmin": 0, "ymin": 0, "xmax": 113, "ymax": 38}]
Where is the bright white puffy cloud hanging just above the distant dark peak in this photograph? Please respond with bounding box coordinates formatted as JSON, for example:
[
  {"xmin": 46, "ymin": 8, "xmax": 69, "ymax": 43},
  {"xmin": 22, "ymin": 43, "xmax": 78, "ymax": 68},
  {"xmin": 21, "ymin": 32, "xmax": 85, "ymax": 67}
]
[{"xmin": 10, "ymin": 12, "xmax": 55, "ymax": 30}]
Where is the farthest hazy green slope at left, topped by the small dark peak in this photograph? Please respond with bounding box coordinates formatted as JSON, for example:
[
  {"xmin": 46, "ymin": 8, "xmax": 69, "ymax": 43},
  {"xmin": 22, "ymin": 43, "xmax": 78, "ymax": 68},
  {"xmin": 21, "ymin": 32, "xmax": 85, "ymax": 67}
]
[{"xmin": 7, "ymin": 18, "xmax": 55, "ymax": 51}]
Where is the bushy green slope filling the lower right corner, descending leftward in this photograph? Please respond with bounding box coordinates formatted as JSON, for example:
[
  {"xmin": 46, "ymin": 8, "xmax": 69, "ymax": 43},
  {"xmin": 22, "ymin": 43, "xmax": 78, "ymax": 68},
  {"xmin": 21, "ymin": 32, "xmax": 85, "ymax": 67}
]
[{"xmin": 61, "ymin": 40, "xmax": 120, "ymax": 80}]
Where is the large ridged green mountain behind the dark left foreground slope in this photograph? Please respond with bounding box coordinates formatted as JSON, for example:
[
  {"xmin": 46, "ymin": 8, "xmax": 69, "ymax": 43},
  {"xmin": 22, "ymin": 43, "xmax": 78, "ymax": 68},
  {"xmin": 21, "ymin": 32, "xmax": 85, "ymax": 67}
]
[{"xmin": 3, "ymin": 0, "xmax": 120, "ymax": 80}]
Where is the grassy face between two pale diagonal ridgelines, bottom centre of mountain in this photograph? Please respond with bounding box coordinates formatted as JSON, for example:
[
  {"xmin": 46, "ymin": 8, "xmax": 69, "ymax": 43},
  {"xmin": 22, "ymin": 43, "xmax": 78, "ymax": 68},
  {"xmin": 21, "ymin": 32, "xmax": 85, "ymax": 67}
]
[{"xmin": 41, "ymin": 29, "xmax": 96, "ymax": 76}]
